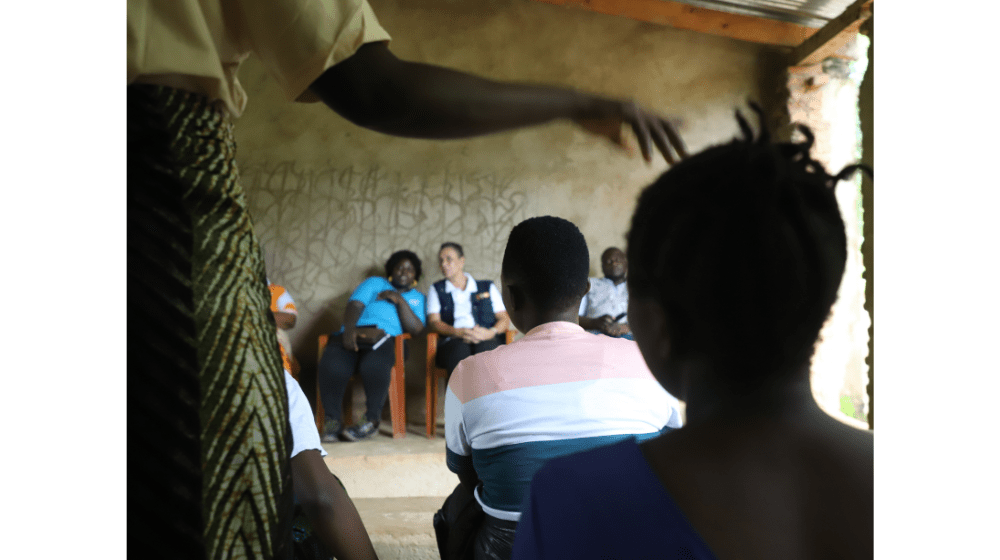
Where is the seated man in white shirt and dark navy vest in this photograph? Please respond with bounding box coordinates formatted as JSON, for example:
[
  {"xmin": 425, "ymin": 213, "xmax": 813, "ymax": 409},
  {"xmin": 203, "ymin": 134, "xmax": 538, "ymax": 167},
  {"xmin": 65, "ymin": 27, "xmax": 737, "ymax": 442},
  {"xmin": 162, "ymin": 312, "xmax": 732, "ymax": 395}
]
[{"xmin": 427, "ymin": 241, "xmax": 510, "ymax": 376}]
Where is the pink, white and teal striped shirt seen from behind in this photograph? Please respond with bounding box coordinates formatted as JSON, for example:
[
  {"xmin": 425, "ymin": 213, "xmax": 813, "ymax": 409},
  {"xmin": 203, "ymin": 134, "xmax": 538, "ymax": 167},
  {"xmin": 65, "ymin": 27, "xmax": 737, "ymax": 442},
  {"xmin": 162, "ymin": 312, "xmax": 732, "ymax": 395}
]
[{"xmin": 444, "ymin": 321, "xmax": 681, "ymax": 521}]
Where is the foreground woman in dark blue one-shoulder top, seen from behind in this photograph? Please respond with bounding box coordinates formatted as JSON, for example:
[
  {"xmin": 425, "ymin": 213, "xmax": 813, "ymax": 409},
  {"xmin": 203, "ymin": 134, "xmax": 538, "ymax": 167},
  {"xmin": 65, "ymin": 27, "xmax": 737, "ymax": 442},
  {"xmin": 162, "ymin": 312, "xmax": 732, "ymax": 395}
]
[{"xmin": 513, "ymin": 107, "xmax": 874, "ymax": 560}]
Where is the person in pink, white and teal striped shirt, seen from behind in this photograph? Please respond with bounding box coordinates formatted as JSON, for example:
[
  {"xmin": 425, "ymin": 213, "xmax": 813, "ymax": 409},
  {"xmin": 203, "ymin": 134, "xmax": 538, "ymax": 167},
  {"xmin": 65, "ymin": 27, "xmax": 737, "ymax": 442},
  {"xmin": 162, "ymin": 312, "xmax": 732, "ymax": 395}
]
[{"xmin": 445, "ymin": 216, "xmax": 681, "ymax": 558}]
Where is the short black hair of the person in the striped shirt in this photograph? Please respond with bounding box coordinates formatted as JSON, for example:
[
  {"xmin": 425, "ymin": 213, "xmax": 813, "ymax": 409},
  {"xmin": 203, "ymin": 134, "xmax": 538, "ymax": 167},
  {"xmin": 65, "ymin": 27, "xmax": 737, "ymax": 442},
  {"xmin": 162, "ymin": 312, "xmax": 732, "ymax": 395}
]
[{"xmin": 502, "ymin": 216, "xmax": 590, "ymax": 310}]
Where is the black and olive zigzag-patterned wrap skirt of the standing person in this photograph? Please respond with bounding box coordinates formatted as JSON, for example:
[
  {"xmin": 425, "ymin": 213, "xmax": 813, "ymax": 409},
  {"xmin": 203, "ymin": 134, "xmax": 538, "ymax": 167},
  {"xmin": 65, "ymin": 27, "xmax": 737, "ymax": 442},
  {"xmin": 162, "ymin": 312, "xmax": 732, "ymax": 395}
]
[{"xmin": 127, "ymin": 84, "xmax": 293, "ymax": 560}]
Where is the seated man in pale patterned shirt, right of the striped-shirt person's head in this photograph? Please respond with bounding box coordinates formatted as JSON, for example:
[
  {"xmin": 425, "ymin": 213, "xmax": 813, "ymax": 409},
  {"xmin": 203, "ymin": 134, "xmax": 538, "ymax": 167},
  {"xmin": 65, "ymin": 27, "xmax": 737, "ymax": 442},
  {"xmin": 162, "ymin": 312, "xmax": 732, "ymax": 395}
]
[{"xmin": 580, "ymin": 247, "xmax": 632, "ymax": 340}]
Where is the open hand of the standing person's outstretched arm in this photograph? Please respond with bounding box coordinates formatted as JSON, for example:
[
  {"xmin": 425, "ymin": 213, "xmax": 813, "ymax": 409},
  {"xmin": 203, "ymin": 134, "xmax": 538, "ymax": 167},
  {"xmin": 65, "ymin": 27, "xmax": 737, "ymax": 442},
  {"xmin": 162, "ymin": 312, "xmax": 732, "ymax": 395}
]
[{"xmin": 574, "ymin": 97, "xmax": 688, "ymax": 165}]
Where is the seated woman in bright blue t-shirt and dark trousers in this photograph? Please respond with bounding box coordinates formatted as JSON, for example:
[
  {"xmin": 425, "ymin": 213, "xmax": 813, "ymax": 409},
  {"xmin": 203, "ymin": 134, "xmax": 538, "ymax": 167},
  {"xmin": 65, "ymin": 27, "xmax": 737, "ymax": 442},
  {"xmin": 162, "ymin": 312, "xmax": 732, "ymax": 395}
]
[{"xmin": 317, "ymin": 251, "xmax": 425, "ymax": 443}]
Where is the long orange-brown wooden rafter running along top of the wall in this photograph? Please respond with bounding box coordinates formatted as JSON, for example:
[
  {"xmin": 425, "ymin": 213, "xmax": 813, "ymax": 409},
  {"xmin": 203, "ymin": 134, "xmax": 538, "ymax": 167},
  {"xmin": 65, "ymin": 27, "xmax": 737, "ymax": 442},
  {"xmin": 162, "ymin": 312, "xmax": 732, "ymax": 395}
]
[{"xmin": 536, "ymin": 0, "xmax": 817, "ymax": 47}]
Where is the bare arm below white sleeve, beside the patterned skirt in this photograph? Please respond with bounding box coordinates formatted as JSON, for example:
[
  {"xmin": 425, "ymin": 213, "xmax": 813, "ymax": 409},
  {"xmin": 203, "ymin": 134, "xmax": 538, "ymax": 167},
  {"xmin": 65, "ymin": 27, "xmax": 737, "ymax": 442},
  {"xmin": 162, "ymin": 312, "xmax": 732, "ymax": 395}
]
[{"xmin": 292, "ymin": 449, "xmax": 378, "ymax": 560}]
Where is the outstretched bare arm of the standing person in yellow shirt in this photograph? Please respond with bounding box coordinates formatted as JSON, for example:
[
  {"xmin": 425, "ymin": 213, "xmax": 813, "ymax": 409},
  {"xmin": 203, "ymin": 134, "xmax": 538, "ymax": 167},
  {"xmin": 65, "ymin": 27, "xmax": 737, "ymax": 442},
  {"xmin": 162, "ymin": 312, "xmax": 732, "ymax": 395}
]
[{"xmin": 309, "ymin": 42, "xmax": 687, "ymax": 163}]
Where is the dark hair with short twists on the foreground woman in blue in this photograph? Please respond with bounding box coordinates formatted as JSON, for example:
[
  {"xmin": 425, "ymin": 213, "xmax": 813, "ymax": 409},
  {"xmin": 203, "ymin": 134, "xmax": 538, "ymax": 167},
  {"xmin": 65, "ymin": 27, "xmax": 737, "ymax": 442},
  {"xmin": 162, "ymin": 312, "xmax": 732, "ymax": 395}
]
[{"xmin": 627, "ymin": 105, "xmax": 871, "ymax": 390}]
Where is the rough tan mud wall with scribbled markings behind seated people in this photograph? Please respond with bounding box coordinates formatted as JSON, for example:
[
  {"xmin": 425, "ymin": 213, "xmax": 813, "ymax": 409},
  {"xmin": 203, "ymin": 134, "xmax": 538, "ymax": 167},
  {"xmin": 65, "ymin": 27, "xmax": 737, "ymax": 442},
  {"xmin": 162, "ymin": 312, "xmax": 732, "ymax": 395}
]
[{"xmin": 236, "ymin": 0, "xmax": 760, "ymax": 419}]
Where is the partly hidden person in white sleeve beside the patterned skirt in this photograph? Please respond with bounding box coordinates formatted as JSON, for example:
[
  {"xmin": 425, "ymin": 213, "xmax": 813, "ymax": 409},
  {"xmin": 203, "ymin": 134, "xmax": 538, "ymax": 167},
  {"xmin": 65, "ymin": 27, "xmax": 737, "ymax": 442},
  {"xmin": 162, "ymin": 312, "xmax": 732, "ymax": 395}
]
[{"xmin": 285, "ymin": 368, "xmax": 378, "ymax": 560}]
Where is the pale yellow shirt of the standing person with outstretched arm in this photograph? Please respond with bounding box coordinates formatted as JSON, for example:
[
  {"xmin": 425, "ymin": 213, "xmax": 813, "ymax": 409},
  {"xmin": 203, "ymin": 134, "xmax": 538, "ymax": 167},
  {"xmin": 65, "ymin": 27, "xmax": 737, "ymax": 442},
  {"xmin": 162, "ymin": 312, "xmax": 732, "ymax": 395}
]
[{"xmin": 128, "ymin": 0, "xmax": 389, "ymax": 116}]
